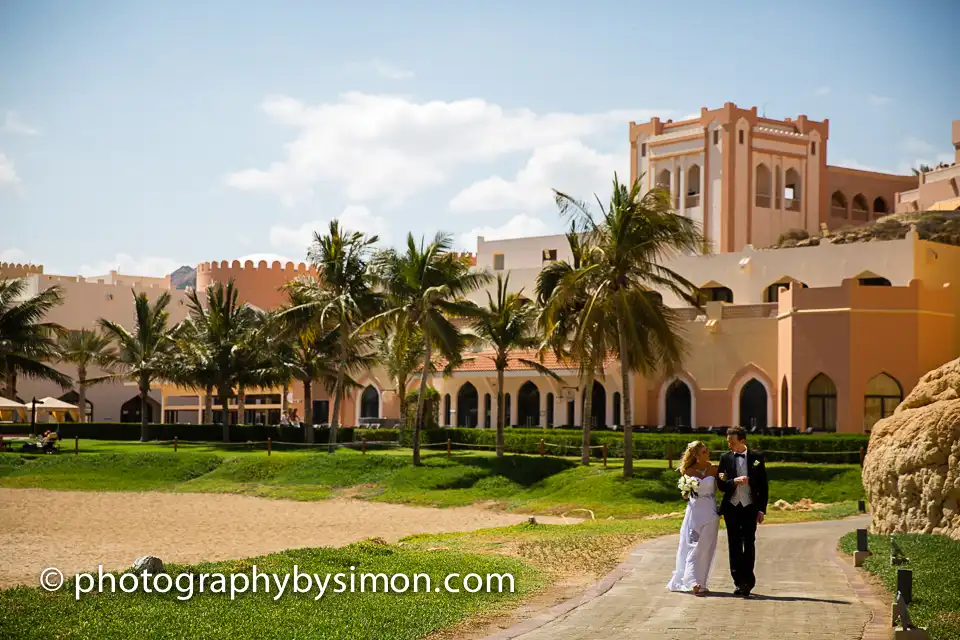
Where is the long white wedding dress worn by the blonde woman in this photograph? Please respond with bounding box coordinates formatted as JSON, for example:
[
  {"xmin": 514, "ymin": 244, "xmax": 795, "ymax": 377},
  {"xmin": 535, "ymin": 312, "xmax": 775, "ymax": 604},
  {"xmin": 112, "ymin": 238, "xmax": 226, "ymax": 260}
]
[{"xmin": 667, "ymin": 476, "xmax": 720, "ymax": 591}]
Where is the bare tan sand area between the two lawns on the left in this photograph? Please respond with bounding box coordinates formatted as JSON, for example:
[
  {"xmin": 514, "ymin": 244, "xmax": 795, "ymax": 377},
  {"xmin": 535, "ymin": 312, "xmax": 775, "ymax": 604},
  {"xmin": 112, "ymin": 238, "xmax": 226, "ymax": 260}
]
[{"xmin": 0, "ymin": 489, "xmax": 578, "ymax": 588}]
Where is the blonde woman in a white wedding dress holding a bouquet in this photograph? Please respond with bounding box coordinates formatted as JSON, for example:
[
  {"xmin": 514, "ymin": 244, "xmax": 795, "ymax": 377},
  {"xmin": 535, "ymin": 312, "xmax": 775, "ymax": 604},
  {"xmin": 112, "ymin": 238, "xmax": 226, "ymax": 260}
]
[{"xmin": 667, "ymin": 440, "xmax": 720, "ymax": 596}]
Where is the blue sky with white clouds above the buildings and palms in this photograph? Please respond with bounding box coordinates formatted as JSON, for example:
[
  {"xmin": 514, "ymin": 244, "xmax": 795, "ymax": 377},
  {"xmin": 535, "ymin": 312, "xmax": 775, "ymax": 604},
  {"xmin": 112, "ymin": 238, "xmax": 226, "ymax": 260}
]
[{"xmin": 0, "ymin": 0, "xmax": 960, "ymax": 275}]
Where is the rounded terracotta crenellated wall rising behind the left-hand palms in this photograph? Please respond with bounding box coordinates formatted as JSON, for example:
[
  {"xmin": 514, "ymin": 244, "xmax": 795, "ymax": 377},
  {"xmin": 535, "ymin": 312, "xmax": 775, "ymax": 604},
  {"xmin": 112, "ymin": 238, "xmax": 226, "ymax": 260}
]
[{"xmin": 197, "ymin": 260, "xmax": 317, "ymax": 310}]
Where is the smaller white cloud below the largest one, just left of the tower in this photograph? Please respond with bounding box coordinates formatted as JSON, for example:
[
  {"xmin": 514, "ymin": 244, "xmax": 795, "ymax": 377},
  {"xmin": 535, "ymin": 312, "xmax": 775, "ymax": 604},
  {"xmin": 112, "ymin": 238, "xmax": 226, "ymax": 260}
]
[{"xmin": 450, "ymin": 140, "xmax": 629, "ymax": 212}]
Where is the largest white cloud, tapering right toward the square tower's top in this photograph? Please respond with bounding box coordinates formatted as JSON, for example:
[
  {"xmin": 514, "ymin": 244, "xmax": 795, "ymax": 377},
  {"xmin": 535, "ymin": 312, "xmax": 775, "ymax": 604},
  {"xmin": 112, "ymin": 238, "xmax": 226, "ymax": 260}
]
[{"xmin": 224, "ymin": 93, "xmax": 669, "ymax": 205}]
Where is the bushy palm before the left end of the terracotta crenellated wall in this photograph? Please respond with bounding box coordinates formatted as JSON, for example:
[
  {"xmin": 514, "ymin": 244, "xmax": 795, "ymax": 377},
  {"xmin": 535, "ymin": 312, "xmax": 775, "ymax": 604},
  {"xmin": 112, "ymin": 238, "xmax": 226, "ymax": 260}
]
[{"xmin": 187, "ymin": 279, "xmax": 255, "ymax": 442}]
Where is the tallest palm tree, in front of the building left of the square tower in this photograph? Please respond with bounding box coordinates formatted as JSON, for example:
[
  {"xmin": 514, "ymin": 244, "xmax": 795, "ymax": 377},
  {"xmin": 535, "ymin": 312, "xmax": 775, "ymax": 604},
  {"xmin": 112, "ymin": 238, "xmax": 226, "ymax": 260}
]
[{"xmin": 556, "ymin": 174, "xmax": 704, "ymax": 476}]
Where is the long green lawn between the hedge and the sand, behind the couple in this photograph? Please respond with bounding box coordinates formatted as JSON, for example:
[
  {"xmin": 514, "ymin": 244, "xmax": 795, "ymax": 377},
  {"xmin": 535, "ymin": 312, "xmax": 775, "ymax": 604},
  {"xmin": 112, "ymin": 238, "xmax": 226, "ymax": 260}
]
[{"xmin": 0, "ymin": 443, "xmax": 863, "ymax": 518}]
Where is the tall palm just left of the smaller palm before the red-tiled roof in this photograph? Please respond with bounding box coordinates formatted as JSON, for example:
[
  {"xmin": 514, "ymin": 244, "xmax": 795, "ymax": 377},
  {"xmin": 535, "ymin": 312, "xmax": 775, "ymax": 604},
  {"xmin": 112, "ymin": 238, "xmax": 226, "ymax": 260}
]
[{"xmin": 360, "ymin": 233, "xmax": 490, "ymax": 465}]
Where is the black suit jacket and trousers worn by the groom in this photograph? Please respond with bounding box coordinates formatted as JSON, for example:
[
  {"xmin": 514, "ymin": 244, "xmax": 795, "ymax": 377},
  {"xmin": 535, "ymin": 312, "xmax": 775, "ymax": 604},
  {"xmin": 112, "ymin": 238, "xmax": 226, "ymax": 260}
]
[{"xmin": 717, "ymin": 449, "xmax": 767, "ymax": 591}]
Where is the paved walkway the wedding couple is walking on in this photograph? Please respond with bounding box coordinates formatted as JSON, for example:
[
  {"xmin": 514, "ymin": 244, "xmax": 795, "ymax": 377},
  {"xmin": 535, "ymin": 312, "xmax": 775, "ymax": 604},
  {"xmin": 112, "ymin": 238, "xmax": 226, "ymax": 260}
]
[{"xmin": 491, "ymin": 517, "xmax": 889, "ymax": 640}]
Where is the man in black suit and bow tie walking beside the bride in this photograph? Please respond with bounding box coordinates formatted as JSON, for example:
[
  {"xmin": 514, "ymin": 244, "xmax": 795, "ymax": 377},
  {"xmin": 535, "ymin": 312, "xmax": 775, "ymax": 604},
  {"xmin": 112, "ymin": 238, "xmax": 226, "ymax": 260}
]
[{"xmin": 717, "ymin": 427, "xmax": 767, "ymax": 598}]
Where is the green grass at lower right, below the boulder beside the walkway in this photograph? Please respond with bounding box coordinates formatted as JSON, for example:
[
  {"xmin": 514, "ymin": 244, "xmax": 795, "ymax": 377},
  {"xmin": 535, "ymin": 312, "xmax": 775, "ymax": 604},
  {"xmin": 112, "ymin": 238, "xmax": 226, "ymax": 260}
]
[{"xmin": 840, "ymin": 532, "xmax": 960, "ymax": 640}]
